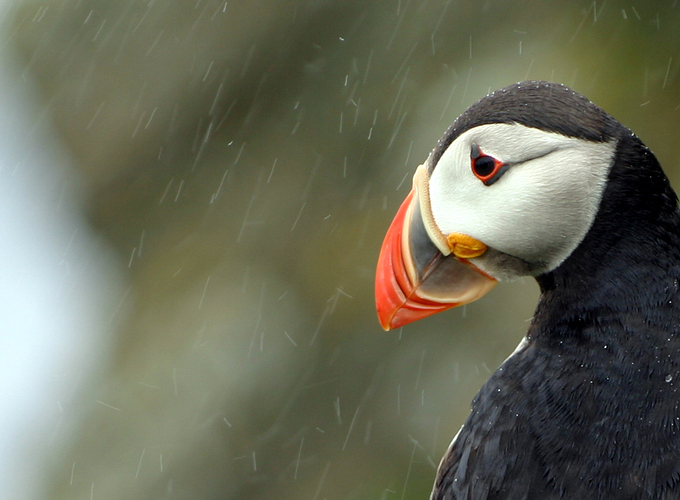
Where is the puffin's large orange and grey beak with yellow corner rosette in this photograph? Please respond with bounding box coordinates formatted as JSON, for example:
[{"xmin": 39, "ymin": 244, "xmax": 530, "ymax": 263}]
[{"xmin": 375, "ymin": 165, "xmax": 496, "ymax": 330}]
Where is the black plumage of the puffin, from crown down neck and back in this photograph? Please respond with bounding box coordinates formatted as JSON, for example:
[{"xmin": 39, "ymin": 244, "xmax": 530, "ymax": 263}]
[{"xmin": 430, "ymin": 82, "xmax": 680, "ymax": 500}]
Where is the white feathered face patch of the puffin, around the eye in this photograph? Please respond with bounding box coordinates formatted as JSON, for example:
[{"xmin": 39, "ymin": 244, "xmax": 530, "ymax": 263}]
[{"xmin": 429, "ymin": 124, "xmax": 616, "ymax": 279}]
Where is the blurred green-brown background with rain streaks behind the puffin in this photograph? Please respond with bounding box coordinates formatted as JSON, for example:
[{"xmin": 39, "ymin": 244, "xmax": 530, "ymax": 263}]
[{"xmin": 0, "ymin": 0, "xmax": 680, "ymax": 500}]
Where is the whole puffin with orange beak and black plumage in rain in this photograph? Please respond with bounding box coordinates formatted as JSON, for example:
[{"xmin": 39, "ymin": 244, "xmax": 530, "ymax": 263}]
[{"xmin": 375, "ymin": 81, "xmax": 680, "ymax": 500}]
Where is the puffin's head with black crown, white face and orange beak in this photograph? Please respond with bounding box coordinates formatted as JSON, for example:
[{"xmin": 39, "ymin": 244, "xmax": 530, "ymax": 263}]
[{"xmin": 376, "ymin": 82, "xmax": 651, "ymax": 330}]
